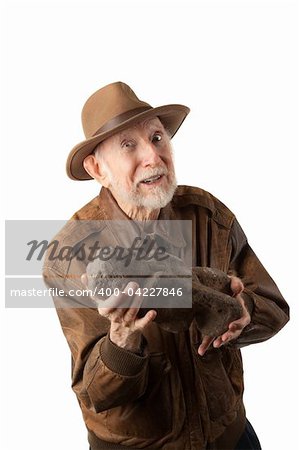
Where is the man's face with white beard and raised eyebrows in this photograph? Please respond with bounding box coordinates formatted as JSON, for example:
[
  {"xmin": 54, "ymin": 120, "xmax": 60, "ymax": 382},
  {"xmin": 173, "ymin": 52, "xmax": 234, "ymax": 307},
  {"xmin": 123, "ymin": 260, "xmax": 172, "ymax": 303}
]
[{"xmin": 96, "ymin": 117, "xmax": 177, "ymax": 211}]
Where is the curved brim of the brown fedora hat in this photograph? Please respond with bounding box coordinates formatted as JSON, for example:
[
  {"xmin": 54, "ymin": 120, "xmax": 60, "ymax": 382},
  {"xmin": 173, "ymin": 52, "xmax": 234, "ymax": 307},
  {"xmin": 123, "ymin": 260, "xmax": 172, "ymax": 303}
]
[{"xmin": 66, "ymin": 105, "xmax": 190, "ymax": 180}]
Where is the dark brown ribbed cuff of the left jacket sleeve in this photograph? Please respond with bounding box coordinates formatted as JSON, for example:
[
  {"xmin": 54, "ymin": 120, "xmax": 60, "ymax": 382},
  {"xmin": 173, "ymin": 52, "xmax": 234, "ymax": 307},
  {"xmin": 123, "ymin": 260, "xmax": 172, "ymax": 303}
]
[{"xmin": 100, "ymin": 335, "xmax": 148, "ymax": 376}]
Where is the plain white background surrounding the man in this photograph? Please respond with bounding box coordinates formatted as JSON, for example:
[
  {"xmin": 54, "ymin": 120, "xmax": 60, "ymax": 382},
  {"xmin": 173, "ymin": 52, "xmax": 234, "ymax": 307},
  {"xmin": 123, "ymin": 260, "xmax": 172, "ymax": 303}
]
[{"xmin": 0, "ymin": 0, "xmax": 299, "ymax": 450}]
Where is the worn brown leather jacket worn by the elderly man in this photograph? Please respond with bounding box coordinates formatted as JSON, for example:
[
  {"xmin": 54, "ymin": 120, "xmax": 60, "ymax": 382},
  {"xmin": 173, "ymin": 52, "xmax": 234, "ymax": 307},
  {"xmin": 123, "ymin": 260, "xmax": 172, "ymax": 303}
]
[{"xmin": 44, "ymin": 186, "xmax": 289, "ymax": 450}]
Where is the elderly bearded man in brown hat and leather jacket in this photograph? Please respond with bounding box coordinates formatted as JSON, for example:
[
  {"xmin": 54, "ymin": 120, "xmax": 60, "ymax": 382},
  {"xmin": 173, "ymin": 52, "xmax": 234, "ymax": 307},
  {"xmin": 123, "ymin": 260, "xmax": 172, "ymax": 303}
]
[{"xmin": 44, "ymin": 82, "xmax": 288, "ymax": 450}]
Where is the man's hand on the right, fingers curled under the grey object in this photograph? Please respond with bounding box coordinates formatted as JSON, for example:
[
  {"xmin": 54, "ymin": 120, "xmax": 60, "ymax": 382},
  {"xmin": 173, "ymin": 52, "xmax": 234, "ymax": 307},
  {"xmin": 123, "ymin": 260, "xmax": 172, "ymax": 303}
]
[{"xmin": 198, "ymin": 276, "xmax": 251, "ymax": 356}]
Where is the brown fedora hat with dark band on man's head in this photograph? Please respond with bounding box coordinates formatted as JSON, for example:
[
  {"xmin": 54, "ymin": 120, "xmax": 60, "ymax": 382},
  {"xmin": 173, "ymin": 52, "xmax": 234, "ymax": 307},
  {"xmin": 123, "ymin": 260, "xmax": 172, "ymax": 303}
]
[{"xmin": 66, "ymin": 81, "xmax": 190, "ymax": 180}]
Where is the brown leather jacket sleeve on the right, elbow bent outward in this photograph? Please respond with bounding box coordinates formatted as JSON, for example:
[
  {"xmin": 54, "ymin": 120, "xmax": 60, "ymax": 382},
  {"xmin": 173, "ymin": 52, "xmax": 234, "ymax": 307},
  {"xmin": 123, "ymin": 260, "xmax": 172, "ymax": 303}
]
[{"xmin": 229, "ymin": 220, "xmax": 289, "ymax": 347}]
